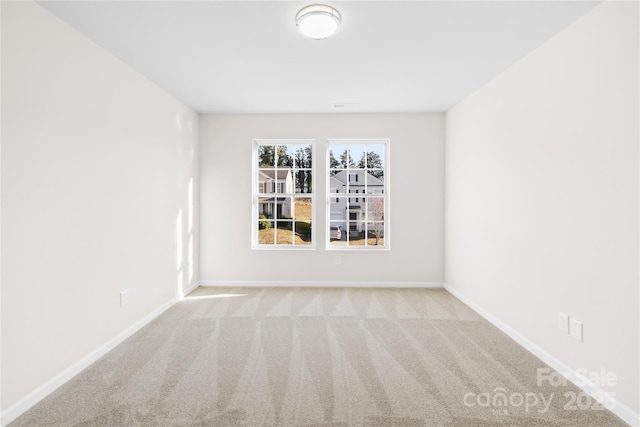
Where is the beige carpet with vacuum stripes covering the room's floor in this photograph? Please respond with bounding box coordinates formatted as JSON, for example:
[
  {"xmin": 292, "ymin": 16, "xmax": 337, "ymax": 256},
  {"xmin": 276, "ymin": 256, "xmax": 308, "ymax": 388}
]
[{"xmin": 11, "ymin": 288, "xmax": 626, "ymax": 427}]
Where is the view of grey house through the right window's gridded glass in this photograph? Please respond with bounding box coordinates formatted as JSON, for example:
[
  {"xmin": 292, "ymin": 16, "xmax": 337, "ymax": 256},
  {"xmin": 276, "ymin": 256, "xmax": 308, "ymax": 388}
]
[{"xmin": 327, "ymin": 140, "xmax": 389, "ymax": 249}]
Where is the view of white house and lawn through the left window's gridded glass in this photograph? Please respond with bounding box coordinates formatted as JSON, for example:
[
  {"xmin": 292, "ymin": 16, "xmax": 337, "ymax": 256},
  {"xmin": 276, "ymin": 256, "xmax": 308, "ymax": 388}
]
[{"xmin": 253, "ymin": 140, "xmax": 314, "ymax": 248}]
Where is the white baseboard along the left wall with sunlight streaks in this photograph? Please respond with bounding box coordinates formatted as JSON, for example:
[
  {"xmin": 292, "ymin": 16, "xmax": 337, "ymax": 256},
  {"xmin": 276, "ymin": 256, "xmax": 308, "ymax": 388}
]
[{"xmin": 0, "ymin": 298, "xmax": 177, "ymax": 427}]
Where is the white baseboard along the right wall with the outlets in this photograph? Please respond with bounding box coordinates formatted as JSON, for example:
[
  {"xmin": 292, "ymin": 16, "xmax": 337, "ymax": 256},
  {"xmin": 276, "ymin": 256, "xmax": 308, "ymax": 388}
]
[{"xmin": 444, "ymin": 283, "xmax": 640, "ymax": 427}]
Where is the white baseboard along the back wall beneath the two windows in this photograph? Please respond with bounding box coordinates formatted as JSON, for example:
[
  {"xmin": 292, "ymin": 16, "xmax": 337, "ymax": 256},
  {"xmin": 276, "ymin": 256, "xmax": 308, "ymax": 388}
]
[{"xmin": 198, "ymin": 280, "xmax": 444, "ymax": 289}]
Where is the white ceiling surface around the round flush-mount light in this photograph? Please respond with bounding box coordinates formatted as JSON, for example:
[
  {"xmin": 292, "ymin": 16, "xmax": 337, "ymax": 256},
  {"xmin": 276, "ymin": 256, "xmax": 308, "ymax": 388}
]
[{"xmin": 40, "ymin": 0, "xmax": 598, "ymax": 113}]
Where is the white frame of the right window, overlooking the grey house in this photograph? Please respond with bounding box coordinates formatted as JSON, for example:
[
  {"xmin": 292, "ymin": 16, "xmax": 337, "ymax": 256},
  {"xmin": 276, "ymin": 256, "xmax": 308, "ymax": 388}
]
[{"xmin": 324, "ymin": 138, "xmax": 391, "ymax": 251}]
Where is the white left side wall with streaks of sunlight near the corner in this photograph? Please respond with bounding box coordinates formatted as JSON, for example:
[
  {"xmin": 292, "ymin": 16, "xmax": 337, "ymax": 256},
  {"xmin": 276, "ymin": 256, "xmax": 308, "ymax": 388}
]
[{"xmin": 2, "ymin": 2, "xmax": 198, "ymax": 422}]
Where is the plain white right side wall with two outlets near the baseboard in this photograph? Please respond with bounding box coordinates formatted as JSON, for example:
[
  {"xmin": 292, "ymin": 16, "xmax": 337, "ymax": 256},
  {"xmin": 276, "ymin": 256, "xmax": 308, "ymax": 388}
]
[{"xmin": 445, "ymin": 2, "xmax": 640, "ymax": 414}]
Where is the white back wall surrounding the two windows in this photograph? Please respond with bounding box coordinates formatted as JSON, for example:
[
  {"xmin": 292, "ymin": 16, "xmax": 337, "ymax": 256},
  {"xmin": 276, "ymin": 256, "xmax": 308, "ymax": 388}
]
[{"xmin": 200, "ymin": 114, "xmax": 444, "ymax": 284}]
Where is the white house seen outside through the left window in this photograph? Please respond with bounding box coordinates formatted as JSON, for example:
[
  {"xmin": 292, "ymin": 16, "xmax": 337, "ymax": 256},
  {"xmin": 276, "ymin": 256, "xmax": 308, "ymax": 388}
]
[{"xmin": 258, "ymin": 168, "xmax": 294, "ymax": 219}]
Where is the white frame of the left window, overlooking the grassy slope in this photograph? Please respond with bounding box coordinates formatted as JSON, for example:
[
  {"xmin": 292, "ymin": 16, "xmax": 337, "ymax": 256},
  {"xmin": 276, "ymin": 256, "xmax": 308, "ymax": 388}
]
[{"xmin": 251, "ymin": 139, "xmax": 318, "ymax": 251}]
